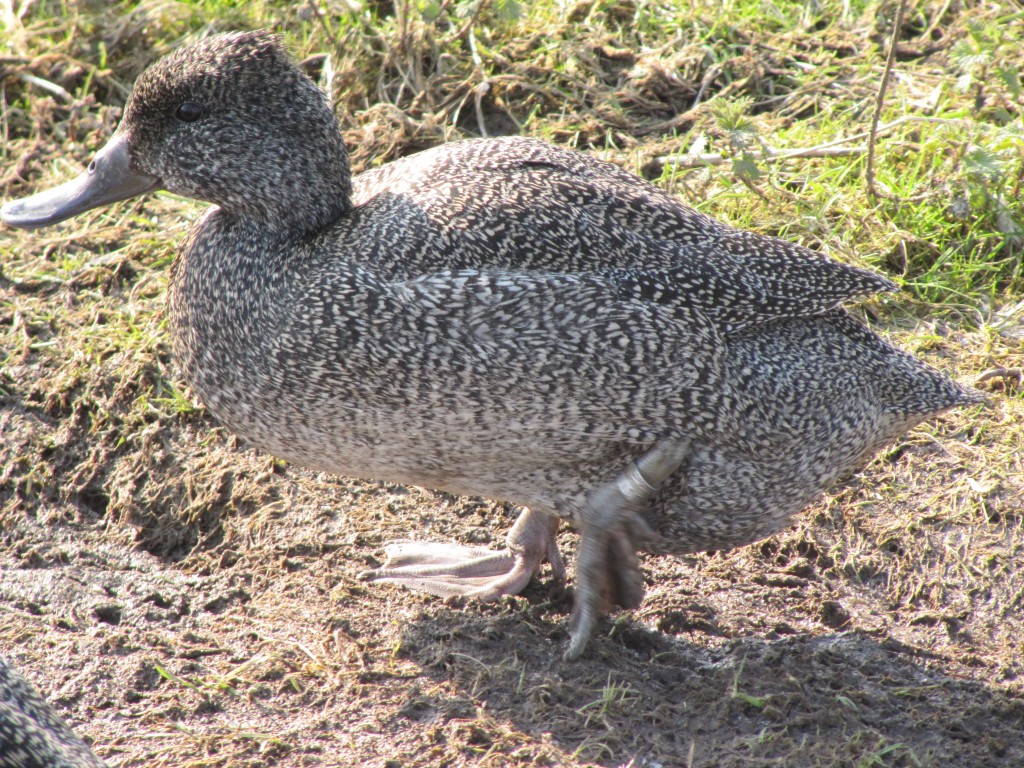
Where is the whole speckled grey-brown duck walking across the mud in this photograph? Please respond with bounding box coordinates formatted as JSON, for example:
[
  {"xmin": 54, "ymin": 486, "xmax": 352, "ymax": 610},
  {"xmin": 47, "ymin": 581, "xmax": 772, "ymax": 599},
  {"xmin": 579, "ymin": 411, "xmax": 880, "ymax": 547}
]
[{"xmin": 0, "ymin": 31, "xmax": 979, "ymax": 659}]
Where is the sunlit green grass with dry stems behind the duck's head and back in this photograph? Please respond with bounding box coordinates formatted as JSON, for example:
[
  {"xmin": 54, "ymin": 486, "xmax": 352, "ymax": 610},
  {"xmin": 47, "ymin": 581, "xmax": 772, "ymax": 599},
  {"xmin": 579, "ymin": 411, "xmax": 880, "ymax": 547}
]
[{"xmin": 0, "ymin": 0, "xmax": 1024, "ymax": 311}]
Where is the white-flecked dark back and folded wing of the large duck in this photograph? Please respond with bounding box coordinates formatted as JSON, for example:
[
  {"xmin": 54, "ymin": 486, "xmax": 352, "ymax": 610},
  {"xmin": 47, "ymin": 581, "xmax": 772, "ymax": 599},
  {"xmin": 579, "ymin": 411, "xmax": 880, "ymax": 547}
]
[{"xmin": 350, "ymin": 138, "xmax": 895, "ymax": 330}]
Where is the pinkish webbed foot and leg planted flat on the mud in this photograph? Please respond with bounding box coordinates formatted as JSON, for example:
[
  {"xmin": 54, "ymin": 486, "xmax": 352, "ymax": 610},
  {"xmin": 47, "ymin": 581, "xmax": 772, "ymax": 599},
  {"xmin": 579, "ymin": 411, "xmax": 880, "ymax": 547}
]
[{"xmin": 359, "ymin": 509, "xmax": 565, "ymax": 600}]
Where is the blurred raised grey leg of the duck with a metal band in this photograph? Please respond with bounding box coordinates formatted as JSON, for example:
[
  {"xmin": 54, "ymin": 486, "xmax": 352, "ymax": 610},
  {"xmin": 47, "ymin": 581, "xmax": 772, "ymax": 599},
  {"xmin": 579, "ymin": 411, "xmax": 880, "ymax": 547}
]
[{"xmin": 565, "ymin": 442, "xmax": 689, "ymax": 660}]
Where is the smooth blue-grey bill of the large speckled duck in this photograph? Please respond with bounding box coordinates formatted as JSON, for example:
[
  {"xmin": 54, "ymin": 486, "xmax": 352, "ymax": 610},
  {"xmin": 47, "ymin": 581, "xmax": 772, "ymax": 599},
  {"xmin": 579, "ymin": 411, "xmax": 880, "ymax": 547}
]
[{"xmin": 0, "ymin": 134, "xmax": 161, "ymax": 229}]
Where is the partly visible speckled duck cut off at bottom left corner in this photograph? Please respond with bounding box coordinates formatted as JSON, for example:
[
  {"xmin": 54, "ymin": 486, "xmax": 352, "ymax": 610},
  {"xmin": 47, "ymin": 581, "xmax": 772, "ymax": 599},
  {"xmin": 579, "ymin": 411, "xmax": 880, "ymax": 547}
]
[{"xmin": 0, "ymin": 656, "xmax": 106, "ymax": 768}]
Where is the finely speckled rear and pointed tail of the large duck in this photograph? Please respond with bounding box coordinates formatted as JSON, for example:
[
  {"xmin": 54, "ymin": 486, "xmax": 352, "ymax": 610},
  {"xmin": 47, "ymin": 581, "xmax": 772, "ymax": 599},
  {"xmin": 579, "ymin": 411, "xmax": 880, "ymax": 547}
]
[{"xmin": 647, "ymin": 309, "xmax": 978, "ymax": 554}]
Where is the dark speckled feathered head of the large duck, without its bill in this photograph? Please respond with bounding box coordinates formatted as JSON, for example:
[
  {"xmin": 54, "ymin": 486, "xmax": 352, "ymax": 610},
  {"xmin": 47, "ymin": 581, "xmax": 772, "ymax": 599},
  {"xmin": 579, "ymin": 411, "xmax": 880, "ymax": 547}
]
[{"xmin": 125, "ymin": 34, "xmax": 351, "ymax": 232}]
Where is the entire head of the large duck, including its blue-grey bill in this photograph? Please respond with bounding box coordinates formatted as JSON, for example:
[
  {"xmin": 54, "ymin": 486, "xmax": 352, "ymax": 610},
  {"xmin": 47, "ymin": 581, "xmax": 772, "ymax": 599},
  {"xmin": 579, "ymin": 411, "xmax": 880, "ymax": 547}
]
[{"xmin": 0, "ymin": 32, "xmax": 350, "ymax": 232}]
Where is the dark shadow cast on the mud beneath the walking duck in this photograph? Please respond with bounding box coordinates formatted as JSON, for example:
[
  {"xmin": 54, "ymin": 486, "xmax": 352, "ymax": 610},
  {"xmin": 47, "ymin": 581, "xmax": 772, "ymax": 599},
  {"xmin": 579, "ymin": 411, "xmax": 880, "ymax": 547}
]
[{"xmin": 396, "ymin": 604, "xmax": 1024, "ymax": 768}]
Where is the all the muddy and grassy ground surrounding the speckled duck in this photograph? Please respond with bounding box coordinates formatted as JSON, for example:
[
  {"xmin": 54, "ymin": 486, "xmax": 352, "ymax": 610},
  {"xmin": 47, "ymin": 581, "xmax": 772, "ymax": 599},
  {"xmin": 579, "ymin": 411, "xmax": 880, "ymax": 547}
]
[{"xmin": 0, "ymin": 0, "xmax": 1024, "ymax": 768}]
